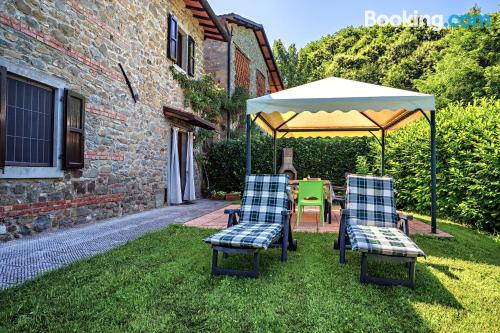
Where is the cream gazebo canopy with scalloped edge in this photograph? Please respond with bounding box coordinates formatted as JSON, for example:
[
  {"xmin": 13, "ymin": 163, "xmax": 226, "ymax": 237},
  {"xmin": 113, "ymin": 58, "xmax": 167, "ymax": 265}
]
[{"xmin": 247, "ymin": 77, "xmax": 434, "ymax": 138}]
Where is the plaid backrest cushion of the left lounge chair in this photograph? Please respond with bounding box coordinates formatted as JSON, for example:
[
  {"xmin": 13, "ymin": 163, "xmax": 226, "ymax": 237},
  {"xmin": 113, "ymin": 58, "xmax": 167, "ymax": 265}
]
[{"xmin": 240, "ymin": 175, "xmax": 289, "ymax": 224}]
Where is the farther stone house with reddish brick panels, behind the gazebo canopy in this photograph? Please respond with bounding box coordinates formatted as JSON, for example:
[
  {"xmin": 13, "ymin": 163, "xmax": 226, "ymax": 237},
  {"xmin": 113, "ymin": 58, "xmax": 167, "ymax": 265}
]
[{"xmin": 204, "ymin": 13, "xmax": 283, "ymax": 133}]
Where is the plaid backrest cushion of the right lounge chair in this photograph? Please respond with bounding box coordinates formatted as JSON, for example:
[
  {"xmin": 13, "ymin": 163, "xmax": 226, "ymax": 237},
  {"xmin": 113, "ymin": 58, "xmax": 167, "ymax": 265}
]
[{"xmin": 346, "ymin": 175, "xmax": 398, "ymax": 227}]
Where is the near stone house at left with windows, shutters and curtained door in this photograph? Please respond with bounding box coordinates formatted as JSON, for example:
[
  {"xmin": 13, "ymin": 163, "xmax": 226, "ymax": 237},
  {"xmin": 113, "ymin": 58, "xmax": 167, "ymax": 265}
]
[{"xmin": 0, "ymin": 0, "xmax": 228, "ymax": 240}]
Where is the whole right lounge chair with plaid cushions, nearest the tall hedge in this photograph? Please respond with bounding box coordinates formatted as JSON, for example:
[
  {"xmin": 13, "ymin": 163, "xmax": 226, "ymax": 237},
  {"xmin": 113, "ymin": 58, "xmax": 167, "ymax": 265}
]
[{"xmin": 334, "ymin": 175, "xmax": 425, "ymax": 288}]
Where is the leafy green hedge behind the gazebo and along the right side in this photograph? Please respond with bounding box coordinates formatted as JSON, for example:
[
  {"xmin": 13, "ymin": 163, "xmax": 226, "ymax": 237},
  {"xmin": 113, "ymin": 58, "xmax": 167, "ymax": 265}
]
[{"xmin": 207, "ymin": 100, "xmax": 500, "ymax": 233}]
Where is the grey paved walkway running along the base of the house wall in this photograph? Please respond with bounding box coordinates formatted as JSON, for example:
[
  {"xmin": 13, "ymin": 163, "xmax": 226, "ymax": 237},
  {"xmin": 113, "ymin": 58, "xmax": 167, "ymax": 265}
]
[{"xmin": 0, "ymin": 200, "xmax": 229, "ymax": 290}]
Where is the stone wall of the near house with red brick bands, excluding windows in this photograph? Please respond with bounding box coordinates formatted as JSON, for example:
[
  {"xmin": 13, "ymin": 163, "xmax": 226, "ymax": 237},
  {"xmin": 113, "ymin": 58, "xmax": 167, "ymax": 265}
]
[{"xmin": 0, "ymin": 0, "xmax": 207, "ymax": 240}]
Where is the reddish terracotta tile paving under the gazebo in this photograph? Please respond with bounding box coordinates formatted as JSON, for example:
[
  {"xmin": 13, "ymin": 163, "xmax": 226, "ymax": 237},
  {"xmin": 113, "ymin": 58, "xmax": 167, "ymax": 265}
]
[{"xmin": 185, "ymin": 205, "xmax": 453, "ymax": 238}]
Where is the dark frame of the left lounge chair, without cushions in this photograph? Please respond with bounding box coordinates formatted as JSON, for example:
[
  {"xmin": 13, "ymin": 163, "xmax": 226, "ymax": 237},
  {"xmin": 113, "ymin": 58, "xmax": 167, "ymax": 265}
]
[{"xmin": 212, "ymin": 209, "xmax": 297, "ymax": 278}]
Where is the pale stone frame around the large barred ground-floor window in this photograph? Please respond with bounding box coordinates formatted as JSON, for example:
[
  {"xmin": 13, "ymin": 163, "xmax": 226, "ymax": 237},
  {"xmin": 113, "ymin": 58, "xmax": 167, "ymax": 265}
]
[{"xmin": 0, "ymin": 58, "xmax": 67, "ymax": 179}]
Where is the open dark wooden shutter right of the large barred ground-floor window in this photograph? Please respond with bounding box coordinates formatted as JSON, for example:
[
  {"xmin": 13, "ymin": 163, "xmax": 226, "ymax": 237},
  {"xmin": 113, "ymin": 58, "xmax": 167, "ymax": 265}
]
[{"xmin": 63, "ymin": 89, "xmax": 85, "ymax": 169}]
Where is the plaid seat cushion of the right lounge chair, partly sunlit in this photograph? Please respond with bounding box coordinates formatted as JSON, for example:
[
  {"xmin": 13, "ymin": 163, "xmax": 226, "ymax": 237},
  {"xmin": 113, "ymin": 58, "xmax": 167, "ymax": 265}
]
[{"xmin": 347, "ymin": 225, "xmax": 425, "ymax": 257}]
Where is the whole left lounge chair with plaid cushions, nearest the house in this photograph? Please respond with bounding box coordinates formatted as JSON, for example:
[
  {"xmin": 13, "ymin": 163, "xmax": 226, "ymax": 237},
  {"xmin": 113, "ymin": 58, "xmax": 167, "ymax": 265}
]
[{"xmin": 203, "ymin": 175, "xmax": 297, "ymax": 277}]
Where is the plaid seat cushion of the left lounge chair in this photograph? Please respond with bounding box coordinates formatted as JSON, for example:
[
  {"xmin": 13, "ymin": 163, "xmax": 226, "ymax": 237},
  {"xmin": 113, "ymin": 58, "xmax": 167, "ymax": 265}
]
[{"xmin": 203, "ymin": 223, "xmax": 282, "ymax": 250}]
